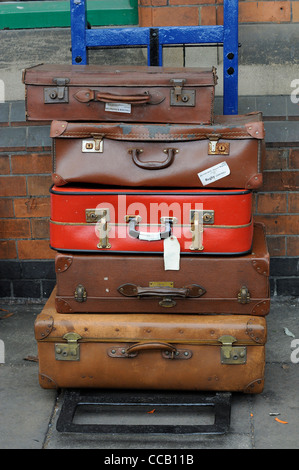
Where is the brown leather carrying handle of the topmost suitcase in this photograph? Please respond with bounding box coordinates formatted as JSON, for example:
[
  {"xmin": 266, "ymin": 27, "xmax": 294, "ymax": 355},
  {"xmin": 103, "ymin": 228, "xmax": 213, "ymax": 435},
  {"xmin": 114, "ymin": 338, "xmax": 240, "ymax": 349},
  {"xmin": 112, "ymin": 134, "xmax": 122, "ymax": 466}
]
[{"xmin": 74, "ymin": 89, "xmax": 151, "ymax": 105}]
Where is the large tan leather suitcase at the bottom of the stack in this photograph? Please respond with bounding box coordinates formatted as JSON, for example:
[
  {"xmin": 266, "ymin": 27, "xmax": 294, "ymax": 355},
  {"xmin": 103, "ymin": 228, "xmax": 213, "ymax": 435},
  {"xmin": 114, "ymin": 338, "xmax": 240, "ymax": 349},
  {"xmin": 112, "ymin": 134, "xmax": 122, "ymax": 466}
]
[{"xmin": 35, "ymin": 286, "xmax": 267, "ymax": 393}]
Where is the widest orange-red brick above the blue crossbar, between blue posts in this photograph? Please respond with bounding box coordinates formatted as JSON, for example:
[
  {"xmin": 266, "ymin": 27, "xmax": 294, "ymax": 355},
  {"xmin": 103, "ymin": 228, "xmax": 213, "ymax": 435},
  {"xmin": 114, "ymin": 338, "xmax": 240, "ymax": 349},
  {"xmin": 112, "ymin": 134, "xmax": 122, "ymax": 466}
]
[{"xmin": 152, "ymin": 7, "xmax": 199, "ymax": 26}]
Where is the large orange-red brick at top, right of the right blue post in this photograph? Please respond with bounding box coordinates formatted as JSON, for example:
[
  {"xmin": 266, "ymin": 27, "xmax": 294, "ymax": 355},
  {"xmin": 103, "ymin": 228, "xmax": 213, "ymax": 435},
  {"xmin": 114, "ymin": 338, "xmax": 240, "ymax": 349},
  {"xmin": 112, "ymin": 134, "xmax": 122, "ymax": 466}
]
[{"xmin": 239, "ymin": 1, "xmax": 291, "ymax": 23}]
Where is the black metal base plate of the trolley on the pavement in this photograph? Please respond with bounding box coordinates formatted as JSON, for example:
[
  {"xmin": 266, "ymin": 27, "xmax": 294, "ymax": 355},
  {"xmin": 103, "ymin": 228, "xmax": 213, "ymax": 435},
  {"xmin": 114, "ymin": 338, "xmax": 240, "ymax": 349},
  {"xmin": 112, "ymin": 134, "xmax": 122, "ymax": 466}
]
[{"xmin": 56, "ymin": 389, "xmax": 231, "ymax": 434}]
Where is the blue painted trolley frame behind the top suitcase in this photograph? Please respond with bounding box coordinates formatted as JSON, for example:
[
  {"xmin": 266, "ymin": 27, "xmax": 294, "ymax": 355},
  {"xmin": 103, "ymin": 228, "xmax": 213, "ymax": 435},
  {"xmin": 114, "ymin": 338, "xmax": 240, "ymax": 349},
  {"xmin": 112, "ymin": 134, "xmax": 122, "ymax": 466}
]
[{"xmin": 70, "ymin": 0, "xmax": 239, "ymax": 114}]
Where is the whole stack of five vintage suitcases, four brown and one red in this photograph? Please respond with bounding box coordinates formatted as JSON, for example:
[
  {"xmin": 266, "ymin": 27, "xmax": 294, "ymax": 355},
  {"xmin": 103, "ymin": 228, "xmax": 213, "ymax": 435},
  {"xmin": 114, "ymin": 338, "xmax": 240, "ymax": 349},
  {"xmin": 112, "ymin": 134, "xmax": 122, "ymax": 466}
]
[{"xmin": 23, "ymin": 65, "xmax": 270, "ymax": 393}]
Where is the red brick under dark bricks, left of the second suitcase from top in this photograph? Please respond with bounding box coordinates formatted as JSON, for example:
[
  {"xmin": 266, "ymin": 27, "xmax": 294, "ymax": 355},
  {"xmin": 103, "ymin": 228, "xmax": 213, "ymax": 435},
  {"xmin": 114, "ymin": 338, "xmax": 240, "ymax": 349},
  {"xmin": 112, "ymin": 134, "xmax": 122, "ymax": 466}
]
[{"xmin": 11, "ymin": 153, "xmax": 52, "ymax": 174}]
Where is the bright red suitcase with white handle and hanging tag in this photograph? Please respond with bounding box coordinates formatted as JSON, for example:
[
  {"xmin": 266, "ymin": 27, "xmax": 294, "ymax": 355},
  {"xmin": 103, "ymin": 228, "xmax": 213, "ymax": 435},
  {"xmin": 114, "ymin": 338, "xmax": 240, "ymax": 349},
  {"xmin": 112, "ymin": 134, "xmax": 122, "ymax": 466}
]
[{"xmin": 50, "ymin": 186, "xmax": 253, "ymax": 258}]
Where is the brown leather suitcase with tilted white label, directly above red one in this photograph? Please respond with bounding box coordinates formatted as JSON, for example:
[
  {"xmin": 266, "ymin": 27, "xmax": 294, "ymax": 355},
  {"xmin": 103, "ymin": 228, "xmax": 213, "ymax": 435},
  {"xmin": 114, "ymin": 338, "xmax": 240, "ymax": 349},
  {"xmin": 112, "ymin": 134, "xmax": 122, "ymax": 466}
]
[{"xmin": 50, "ymin": 112, "xmax": 265, "ymax": 189}]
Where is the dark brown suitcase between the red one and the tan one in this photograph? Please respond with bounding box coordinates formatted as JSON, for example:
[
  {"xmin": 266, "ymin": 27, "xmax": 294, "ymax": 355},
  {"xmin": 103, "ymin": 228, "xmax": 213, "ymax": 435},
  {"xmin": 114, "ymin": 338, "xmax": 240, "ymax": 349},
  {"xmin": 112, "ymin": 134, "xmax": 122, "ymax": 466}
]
[{"xmin": 55, "ymin": 223, "xmax": 270, "ymax": 316}]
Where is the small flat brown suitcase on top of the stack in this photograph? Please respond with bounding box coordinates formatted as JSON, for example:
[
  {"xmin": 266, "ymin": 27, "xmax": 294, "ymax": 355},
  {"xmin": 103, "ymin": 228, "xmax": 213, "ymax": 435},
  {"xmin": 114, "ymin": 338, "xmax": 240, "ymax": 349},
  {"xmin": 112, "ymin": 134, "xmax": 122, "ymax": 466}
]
[{"xmin": 23, "ymin": 64, "xmax": 217, "ymax": 123}]
